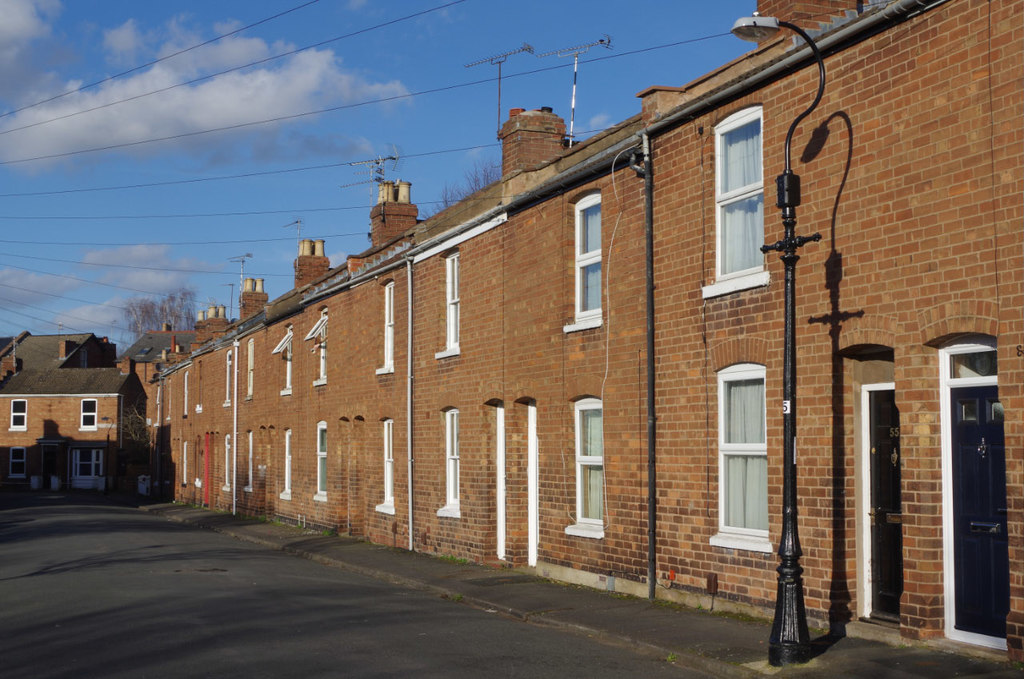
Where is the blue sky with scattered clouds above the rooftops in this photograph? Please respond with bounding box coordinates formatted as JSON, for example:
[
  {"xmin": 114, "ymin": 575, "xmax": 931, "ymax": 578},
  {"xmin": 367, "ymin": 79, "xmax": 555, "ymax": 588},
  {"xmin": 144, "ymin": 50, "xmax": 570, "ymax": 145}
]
[{"xmin": 0, "ymin": 0, "xmax": 756, "ymax": 348}]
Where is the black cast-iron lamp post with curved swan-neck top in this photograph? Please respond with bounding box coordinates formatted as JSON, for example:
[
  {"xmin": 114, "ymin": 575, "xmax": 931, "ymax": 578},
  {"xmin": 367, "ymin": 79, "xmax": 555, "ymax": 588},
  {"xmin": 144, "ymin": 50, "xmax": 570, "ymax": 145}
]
[{"xmin": 732, "ymin": 13, "xmax": 825, "ymax": 667}]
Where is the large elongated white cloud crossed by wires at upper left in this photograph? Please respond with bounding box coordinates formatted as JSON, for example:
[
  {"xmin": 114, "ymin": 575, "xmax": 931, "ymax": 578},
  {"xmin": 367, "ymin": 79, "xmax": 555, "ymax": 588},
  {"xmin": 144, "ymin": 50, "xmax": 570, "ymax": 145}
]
[{"xmin": 0, "ymin": 15, "xmax": 408, "ymax": 166}]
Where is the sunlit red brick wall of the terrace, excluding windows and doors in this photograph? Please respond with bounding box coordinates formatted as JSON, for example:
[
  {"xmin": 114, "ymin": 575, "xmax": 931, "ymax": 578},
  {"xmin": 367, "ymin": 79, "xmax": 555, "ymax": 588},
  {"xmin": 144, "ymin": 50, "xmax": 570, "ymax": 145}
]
[{"xmin": 159, "ymin": 1, "xmax": 1024, "ymax": 656}]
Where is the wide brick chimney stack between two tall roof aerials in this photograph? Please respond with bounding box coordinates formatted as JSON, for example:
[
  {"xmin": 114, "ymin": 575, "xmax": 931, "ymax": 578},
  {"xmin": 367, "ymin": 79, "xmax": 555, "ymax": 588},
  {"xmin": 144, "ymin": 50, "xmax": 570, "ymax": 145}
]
[{"xmin": 498, "ymin": 107, "xmax": 565, "ymax": 177}]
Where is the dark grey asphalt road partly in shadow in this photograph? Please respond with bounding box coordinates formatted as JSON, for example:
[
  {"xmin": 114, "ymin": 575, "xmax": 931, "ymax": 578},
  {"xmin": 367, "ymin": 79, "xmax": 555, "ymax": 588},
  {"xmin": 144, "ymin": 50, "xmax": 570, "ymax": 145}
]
[{"xmin": 0, "ymin": 493, "xmax": 702, "ymax": 679}]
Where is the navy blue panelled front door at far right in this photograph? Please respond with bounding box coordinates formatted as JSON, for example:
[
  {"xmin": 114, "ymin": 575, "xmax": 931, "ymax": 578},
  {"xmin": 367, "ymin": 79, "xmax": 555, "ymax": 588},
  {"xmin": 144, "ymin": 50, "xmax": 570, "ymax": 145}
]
[{"xmin": 949, "ymin": 386, "xmax": 1010, "ymax": 637}]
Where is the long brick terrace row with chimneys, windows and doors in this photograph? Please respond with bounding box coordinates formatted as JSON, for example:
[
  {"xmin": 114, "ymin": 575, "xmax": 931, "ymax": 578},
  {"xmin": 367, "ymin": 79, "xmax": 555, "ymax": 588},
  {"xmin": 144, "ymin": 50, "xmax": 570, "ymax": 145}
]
[{"xmin": 159, "ymin": 0, "xmax": 1024, "ymax": 660}]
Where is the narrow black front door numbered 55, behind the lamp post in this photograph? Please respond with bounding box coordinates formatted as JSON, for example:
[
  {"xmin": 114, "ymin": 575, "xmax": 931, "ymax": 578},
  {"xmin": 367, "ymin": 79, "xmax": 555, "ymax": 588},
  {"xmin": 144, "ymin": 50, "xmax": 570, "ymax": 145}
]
[{"xmin": 869, "ymin": 389, "xmax": 903, "ymax": 622}]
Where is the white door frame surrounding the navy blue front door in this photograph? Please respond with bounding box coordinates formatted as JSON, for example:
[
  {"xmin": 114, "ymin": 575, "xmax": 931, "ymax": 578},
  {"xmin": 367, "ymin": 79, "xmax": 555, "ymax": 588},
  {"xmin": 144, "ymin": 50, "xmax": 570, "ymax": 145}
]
[{"xmin": 939, "ymin": 337, "xmax": 1007, "ymax": 650}]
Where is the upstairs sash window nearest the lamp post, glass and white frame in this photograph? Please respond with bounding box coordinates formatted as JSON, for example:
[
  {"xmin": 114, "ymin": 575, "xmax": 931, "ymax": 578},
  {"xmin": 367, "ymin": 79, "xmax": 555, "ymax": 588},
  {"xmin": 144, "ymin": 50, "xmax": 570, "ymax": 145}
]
[{"xmin": 715, "ymin": 108, "xmax": 764, "ymax": 292}]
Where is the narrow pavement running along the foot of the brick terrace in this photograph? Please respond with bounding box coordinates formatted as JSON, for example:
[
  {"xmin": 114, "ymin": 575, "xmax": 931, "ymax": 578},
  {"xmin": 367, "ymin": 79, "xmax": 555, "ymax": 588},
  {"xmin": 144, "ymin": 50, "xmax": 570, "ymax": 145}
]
[{"xmin": 139, "ymin": 503, "xmax": 1024, "ymax": 679}]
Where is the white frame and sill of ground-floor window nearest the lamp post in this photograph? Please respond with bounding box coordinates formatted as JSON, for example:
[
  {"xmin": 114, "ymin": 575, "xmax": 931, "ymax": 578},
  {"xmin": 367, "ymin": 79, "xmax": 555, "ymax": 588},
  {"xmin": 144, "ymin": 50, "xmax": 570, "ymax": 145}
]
[{"xmin": 711, "ymin": 364, "xmax": 772, "ymax": 553}]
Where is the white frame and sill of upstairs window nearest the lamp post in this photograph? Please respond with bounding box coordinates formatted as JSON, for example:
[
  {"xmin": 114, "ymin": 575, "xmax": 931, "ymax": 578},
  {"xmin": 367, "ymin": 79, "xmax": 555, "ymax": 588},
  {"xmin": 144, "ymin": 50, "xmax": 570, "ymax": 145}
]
[{"xmin": 701, "ymin": 107, "xmax": 769, "ymax": 299}]
